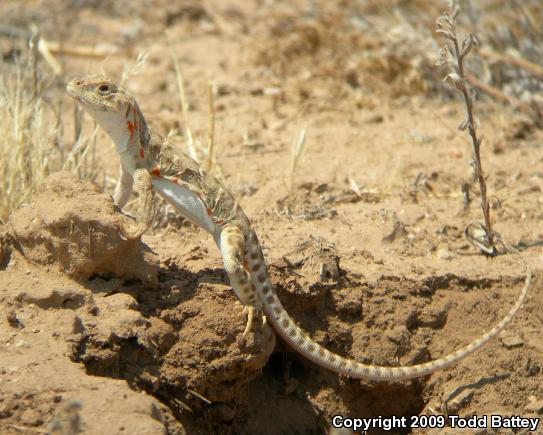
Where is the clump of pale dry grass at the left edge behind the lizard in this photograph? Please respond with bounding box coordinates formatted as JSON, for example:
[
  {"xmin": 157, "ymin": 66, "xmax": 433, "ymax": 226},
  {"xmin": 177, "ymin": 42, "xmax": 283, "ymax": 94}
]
[{"xmin": 0, "ymin": 37, "xmax": 97, "ymax": 223}]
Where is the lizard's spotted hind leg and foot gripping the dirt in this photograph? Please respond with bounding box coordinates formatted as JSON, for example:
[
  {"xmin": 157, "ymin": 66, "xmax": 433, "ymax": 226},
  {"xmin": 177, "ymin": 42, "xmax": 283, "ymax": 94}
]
[{"xmin": 219, "ymin": 225, "xmax": 262, "ymax": 338}]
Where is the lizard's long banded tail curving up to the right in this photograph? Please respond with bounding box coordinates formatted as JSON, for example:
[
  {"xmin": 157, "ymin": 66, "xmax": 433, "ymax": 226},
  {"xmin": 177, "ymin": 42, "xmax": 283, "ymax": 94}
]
[{"xmin": 249, "ymin": 238, "xmax": 532, "ymax": 381}]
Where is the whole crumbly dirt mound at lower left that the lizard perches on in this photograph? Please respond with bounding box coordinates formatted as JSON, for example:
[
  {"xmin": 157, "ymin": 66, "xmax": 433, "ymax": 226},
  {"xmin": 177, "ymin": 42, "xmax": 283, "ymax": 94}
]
[{"xmin": 0, "ymin": 173, "xmax": 275, "ymax": 434}]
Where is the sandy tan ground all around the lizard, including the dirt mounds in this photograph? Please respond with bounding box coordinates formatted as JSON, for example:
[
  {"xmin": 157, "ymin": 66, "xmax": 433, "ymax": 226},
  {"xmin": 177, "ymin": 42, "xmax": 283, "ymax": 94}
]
[{"xmin": 0, "ymin": 1, "xmax": 543, "ymax": 434}]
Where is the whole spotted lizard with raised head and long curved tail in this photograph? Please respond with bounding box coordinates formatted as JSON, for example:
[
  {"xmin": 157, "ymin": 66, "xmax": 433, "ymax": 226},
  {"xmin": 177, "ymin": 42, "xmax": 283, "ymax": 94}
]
[{"xmin": 67, "ymin": 75, "xmax": 530, "ymax": 381}]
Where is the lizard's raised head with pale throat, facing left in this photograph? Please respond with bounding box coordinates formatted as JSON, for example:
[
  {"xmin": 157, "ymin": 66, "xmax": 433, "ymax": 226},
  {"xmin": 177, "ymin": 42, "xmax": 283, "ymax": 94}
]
[{"xmin": 66, "ymin": 75, "xmax": 146, "ymax": 151}]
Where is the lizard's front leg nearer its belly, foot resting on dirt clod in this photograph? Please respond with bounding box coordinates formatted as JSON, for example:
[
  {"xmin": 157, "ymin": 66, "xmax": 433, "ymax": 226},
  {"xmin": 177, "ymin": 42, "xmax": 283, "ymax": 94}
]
[{"xmin": 120, "ymin": 169, "xmax": 154, "ymax": 240}]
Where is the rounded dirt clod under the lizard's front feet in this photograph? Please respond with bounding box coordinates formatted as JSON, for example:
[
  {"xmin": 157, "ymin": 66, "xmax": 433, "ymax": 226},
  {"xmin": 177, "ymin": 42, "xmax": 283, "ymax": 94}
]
[{"xmin": 6, "ymin": 172, "xmax": 157, "ymax": 282}]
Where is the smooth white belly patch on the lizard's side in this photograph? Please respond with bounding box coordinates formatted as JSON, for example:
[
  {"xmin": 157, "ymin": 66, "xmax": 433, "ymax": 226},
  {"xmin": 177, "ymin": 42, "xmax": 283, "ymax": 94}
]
[{"xmin": 153, "ymin": 178, "xmax": 216, "ymax": 235}]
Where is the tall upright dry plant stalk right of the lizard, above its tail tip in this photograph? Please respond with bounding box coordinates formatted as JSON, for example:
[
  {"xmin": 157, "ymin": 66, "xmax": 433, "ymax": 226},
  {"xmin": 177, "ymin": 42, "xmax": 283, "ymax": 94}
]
[{"xmin": 436, "ymin": 0, "xmax": 497, "ymax": 255}]
